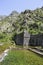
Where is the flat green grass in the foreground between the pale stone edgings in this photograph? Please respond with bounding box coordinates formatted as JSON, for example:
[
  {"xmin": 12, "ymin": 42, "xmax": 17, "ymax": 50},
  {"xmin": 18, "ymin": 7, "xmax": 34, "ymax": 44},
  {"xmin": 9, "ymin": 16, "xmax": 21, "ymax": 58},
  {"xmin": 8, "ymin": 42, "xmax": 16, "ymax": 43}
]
[{"xmin": 0, "ymin": 49, "xmax": 43, "ymax": 65}]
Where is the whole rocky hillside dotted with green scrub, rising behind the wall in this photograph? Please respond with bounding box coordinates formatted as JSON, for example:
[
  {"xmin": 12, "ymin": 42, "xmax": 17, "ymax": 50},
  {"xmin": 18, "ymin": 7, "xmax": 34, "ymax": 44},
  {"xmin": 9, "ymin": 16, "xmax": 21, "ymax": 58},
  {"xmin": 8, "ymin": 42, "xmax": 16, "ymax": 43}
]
[{"xmin": 0, "ymin": 7, "xmax": 43, "ymax": 43}]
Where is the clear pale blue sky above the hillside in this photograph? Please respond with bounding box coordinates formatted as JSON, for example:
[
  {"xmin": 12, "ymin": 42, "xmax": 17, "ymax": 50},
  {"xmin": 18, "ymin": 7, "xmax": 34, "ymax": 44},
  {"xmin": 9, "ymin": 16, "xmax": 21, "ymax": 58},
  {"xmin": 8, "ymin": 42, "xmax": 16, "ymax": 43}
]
[{"xmin": 0, "ymin": 0, "xmax": 43, "ymax": 15}]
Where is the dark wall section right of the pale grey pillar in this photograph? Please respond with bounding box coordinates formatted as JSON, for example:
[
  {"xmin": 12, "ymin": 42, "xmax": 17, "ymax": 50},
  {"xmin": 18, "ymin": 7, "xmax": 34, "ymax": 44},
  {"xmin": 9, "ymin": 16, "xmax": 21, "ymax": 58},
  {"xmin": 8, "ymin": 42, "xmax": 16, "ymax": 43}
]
[{"xmin": 29, "ymin": 34, "xmax": 43, "ymax": 46}]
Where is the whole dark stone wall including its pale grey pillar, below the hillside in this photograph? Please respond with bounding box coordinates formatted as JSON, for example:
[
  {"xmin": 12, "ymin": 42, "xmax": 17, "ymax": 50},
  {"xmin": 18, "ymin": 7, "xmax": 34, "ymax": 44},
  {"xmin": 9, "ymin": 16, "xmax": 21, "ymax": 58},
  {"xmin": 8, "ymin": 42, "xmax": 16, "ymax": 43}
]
[{"xmin": 15, "ymin": 32, "xmax": 43, "ymax": 46}]
